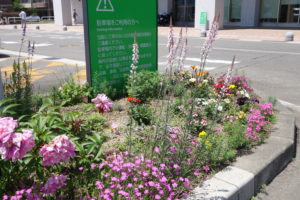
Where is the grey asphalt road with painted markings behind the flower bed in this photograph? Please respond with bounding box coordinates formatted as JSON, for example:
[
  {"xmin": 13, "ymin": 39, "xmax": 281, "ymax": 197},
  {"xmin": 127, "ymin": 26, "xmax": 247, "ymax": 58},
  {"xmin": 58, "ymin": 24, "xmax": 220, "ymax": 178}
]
[{"xmin": 0, "ymin": 29, "xmax": 300, "ymax": 200}]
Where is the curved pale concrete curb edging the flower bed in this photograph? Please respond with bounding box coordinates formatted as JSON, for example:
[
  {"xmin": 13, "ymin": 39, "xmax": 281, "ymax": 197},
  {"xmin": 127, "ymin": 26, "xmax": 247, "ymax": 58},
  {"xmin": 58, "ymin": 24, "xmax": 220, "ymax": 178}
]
[{"xmin": 187, "ymin": 105, "xmax": 297, "ymax": 200}]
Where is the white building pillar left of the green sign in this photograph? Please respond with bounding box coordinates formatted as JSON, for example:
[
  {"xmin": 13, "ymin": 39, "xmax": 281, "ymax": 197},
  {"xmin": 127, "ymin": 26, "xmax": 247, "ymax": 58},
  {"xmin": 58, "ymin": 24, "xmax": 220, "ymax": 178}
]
[{"xmin": 53, "ymin": 0, "xmax": 72, "ymax": 26}]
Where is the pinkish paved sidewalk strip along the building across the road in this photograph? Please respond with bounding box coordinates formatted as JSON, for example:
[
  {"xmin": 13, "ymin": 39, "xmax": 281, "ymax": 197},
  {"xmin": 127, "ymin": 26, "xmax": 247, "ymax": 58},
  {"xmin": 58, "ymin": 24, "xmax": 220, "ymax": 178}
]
[{"xmin": 0, "ymin": 23, "xmax": 300, "ymax": 42}]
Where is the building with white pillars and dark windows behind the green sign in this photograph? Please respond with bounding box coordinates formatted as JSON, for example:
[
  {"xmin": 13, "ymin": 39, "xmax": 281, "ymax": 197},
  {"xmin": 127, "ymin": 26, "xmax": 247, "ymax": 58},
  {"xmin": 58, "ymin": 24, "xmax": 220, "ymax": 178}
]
[{"xmin": 52, "ymin": 0, "xmax": 300, "ymax": 28}]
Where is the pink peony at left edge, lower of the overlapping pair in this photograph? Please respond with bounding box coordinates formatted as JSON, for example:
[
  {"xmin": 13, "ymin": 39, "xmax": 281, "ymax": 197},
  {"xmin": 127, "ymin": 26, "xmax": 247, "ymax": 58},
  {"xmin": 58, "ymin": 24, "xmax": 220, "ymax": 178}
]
[{"xmin": 0, "ymin": 130, "xmax": 34, "ymax": 162}]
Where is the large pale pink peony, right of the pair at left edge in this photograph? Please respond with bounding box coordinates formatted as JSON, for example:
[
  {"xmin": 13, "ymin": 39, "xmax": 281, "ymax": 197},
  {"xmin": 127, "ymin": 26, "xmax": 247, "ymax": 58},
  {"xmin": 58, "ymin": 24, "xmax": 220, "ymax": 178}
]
[{"xmin": 40, "ymin": 135, "xmax": 76, "ymax": 166}]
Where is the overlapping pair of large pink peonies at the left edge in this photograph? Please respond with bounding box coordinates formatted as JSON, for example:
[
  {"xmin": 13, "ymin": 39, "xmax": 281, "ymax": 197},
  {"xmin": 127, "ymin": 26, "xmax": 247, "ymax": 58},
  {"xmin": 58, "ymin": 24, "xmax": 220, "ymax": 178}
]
[{"xmin": 0, "ymin": 117, "xmax": 34, "ymax": 162}]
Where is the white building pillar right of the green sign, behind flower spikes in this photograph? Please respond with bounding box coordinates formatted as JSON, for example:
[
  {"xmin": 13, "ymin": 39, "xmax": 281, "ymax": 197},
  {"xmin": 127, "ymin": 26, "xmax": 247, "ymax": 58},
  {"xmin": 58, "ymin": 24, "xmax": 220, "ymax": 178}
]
[{"xmin": 195, "ymin": 0, "xmax": 224, "ymax": 29}]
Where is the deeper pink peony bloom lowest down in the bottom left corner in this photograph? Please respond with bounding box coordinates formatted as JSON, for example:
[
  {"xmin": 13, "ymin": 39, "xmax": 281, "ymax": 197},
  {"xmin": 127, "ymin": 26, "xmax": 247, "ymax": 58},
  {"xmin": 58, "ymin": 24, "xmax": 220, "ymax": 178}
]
[{"xmin": 41, "ymin": 174, "xmax": 67, "ymax": 194}]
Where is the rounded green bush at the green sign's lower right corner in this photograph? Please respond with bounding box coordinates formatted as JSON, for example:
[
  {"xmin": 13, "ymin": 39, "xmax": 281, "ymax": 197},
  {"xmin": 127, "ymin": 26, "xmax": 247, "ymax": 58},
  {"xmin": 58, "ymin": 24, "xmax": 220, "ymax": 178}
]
[{"xmin": 126, "ymin": 71, "xmax": 163, "ymax": 101}]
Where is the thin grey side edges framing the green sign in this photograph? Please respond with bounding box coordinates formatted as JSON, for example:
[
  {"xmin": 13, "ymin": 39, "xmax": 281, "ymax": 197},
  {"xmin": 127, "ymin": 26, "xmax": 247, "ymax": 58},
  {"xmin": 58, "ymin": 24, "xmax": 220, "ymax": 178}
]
[{"xmin": 82, "ymin": 0, "xmax": 158, "ymax": 91}]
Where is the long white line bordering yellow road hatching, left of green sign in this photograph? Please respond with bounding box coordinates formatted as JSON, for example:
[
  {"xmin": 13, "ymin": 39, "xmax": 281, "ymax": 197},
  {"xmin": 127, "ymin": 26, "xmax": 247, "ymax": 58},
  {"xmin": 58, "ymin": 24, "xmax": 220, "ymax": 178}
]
[{"xmin": 0, "ymin": 49, "xmax": 86, "ymax": 66}]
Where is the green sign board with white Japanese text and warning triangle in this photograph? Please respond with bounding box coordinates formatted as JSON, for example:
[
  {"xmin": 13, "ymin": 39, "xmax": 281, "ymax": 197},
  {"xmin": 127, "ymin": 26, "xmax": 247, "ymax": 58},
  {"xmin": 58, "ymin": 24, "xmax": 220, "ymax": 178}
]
[{"xmin": 83, "ymin": 0, "xmax": 157, "ymax": 93}]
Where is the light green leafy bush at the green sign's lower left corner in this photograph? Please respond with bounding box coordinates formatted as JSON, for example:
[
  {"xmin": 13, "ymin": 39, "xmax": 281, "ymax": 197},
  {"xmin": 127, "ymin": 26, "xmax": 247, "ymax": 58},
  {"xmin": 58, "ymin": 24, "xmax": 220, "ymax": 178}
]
[{"xmin": 58, "ymin": 80, "xmax": 91, "ymax": 106}]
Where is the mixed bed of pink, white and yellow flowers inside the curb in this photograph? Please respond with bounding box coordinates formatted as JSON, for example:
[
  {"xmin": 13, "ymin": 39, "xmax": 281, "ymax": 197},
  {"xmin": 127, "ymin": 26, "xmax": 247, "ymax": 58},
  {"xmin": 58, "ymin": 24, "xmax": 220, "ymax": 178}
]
[{"xmin": 0, "ymin": 19, "xmax": 275, "ymax": 200}]
